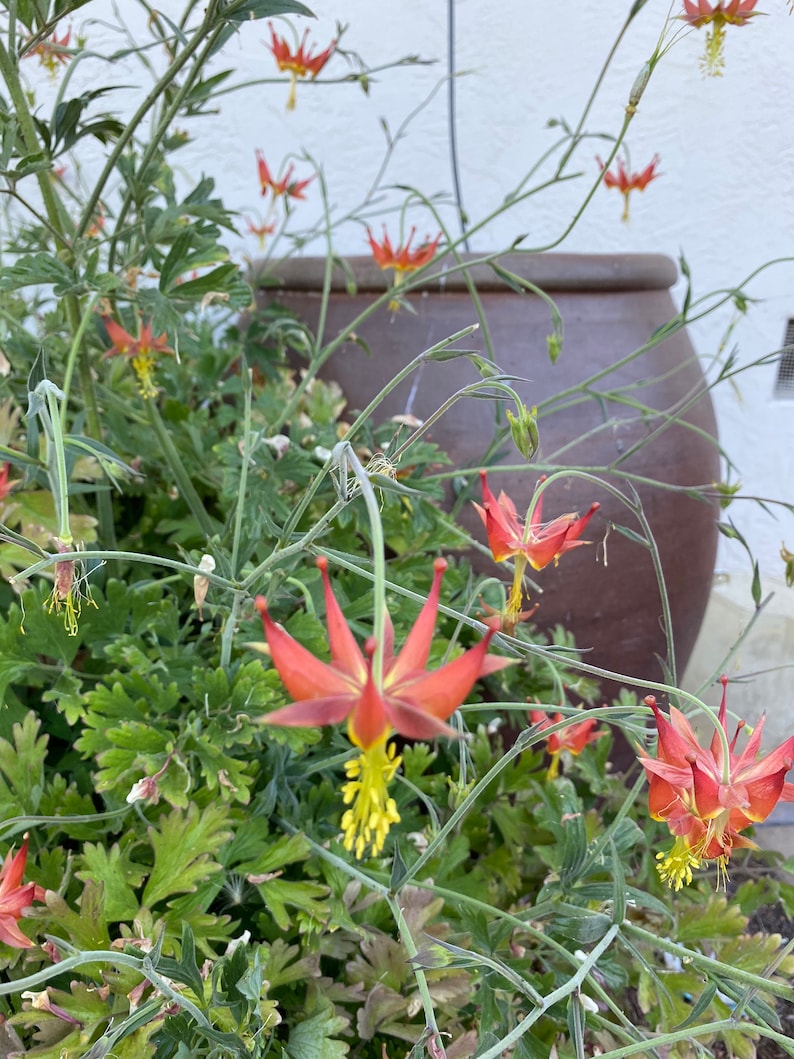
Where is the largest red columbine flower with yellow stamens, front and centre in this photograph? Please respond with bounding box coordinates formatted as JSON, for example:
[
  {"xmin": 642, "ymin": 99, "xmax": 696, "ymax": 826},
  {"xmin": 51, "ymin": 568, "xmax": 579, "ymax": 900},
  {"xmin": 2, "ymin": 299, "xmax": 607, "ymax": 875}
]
[{"xmin": 255, "ymin": 556, "xmax": 509, "ymax": 858}]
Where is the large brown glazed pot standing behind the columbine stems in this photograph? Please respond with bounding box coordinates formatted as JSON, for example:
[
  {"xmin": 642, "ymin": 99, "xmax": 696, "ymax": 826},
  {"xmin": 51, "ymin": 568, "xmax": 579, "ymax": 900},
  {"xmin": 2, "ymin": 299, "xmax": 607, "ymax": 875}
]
[{"xmin": 261, "ymin": 254, "xmax": 720, "ymax": 679}]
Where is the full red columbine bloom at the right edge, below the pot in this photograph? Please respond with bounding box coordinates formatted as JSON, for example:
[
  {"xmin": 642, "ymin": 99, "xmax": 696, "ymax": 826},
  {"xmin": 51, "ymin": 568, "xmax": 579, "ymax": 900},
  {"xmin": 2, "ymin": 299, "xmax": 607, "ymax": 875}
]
[{"xmin": 639, "ymin": 677, "xmax": 794, "ymax": 890}]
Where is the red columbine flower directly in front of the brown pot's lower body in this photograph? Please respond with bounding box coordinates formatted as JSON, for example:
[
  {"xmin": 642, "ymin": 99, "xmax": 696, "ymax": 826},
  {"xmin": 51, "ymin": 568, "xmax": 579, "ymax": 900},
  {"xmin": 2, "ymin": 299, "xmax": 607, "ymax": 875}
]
[{"xmin": 474, "ymin": 470, "xmax": 600, "ymax": 623}]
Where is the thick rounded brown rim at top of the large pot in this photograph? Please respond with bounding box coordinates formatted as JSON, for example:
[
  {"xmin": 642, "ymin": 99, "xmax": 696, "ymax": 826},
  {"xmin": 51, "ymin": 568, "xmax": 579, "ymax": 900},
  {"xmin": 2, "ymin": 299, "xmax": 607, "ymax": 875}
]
[{"xmin": 254, "ymin": 253, "xmax": 679, "ymax": 293}]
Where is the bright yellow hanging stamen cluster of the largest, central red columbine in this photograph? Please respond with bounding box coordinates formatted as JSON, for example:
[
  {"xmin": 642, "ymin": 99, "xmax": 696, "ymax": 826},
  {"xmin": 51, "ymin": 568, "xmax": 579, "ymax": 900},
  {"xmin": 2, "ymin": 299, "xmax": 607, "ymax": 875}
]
[{"xmin": 342, "ymin": 741, "xmax": 402, "ymax": 860}]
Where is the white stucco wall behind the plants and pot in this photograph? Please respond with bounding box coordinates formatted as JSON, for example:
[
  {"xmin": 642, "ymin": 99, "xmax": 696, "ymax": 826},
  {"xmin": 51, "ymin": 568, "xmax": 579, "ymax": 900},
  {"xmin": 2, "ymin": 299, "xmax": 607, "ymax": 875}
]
[{"xmin": 17, "ymin": 0, "xmax": 794, "ymax": 607}]
